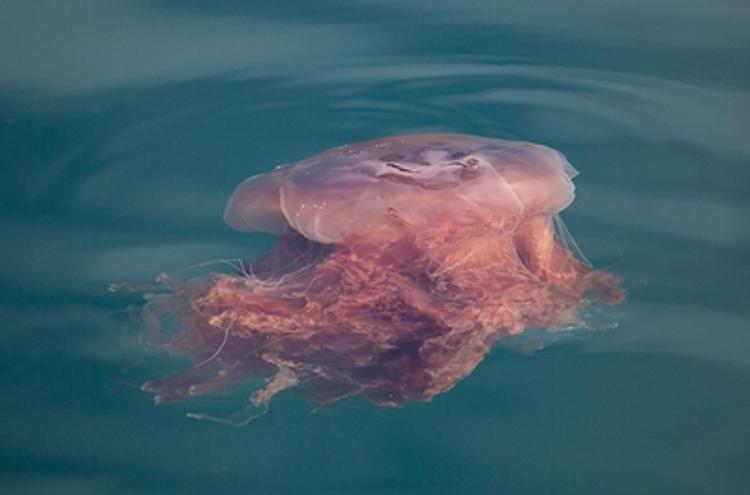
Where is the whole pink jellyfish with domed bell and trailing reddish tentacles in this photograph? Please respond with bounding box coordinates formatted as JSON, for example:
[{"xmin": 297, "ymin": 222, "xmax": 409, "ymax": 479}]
[{"xmin": 128, "ymin": 134, "xmax": 623, "ymax": 422}]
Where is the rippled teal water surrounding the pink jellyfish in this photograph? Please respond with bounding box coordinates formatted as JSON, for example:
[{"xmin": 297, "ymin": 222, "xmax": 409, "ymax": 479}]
[{"xmin": 0, "ymin": 0, "xmax": 750, "ymax": 495}]
